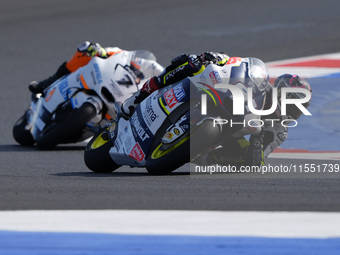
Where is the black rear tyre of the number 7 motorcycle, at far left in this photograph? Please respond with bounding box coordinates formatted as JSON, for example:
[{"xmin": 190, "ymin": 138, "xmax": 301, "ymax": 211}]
[{"xmin": 13, "ymin": 113, "xmax": 35, "ymax": 146}]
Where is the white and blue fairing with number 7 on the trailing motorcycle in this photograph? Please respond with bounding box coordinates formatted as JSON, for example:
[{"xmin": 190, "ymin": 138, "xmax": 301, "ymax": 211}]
[{"xmin": 28, "ymin": 51, "xmax": 145, "ymax": 139}]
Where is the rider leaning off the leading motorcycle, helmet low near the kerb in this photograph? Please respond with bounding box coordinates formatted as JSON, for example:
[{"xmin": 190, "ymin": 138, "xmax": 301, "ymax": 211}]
[{"xmin": 121, "ymin": 52, "xmax": 311, "ymax": 166}]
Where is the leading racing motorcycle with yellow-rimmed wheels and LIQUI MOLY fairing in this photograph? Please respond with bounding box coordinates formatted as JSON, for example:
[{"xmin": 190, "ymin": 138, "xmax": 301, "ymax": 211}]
[{"xmin": 84, "ymin": 58, "xmax": 269, "ymax": 175}]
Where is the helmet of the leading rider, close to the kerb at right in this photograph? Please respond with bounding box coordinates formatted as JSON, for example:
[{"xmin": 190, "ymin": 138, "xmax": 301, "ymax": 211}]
[{"xmin": 274, "ymin": 74, "xmax": 312, "ymax": 120}]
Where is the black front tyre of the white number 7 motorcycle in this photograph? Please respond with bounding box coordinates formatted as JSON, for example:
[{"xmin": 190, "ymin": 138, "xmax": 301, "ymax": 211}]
[{"xmin": 37, "ymin": 103, "xmax": 96, "ymax": 149}]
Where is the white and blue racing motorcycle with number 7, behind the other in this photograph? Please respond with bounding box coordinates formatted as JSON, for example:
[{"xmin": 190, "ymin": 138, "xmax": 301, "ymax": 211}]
[{"xmin": 13, "ymin": 50, "xmax": 164, "ymax": 149}]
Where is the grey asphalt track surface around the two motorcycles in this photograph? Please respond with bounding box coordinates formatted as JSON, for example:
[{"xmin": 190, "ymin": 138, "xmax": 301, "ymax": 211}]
[{"xmin": 0, "ymin": 0, "xmax": 340, "ymax": 211}]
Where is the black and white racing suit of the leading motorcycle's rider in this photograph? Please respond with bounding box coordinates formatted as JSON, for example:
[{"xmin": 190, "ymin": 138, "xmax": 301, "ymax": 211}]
[{"xmin": 129, "ymin": 52, "xmax": 287, "ymax": 166}]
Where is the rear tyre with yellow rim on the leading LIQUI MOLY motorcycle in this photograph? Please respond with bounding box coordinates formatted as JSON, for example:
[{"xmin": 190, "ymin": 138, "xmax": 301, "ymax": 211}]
[{"xmin": 84, "ymin": 129, "xmax": 120, "ymax": 173}]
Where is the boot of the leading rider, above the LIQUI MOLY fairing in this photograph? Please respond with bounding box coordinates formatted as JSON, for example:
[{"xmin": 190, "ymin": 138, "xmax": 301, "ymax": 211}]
[{"xmin": 121, "ymin": 77, "xmax": 159, "ymax": 118}]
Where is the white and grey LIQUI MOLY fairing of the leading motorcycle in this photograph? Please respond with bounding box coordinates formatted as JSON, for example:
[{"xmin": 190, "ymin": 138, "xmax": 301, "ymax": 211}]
[{"xmin": 109, "ymin": 60, "xmax": 270, "ymax": 167}]
